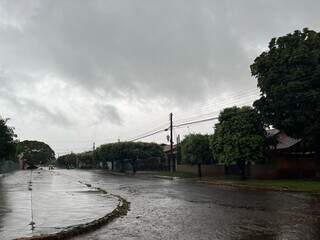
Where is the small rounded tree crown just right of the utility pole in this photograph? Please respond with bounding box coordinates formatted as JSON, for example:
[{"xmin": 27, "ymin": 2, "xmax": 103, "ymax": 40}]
[{"xmin": 180, "ymin": 134, "xmax": 213, "ymax": 164}]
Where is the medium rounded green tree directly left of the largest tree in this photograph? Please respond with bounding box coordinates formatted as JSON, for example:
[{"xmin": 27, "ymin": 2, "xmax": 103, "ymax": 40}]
[{"xmin": 210, "ymin": 106, "xmax": 268, "ymax": 176}]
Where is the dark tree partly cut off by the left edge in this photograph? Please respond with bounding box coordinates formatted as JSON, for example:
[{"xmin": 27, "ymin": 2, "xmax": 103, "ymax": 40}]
[{"xmin": 0, "ymin": 118, "xmax": 17, "ymax": 162}]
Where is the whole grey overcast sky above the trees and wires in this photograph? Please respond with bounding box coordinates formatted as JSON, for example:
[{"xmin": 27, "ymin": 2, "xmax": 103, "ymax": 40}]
[{"xmin": 0, "ymin": 0, "xmax": 320, "ymax": 154}]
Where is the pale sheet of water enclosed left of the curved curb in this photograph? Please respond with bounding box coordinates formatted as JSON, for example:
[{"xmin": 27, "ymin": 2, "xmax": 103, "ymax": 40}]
[{"xmin": 0, "ymin": 170, "xmax": 118, "ymax": 240}]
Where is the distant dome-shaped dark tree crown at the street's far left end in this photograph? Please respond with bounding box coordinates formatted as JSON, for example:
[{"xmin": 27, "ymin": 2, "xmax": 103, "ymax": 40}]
[{"xmin": 17, "ymin": 140, "xmax": 55, "ymax": 165}]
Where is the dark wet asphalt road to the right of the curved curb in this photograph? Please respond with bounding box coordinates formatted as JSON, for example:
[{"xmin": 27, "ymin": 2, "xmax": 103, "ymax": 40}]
[{"xmin": 61, "ymin": 170, "xmax": 320, "ymax": 240}]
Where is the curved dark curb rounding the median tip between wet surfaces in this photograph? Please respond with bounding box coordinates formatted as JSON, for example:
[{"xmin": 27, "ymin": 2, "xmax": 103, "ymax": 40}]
[{"xmin": 15, "ymin": 182, "xmax": 130, "ymax": 240}]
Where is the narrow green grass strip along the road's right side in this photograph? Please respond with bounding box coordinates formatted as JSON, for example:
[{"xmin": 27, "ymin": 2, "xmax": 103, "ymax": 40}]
[{"xmin": 202, "ymin": 179, "xmax": 320, "ymax": 193}]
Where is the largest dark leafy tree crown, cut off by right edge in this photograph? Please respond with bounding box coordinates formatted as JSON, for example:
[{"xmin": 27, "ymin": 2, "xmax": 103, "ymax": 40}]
[{"xmin": 251, "ymin": 28, "xmax": 320, "ymax": 152}]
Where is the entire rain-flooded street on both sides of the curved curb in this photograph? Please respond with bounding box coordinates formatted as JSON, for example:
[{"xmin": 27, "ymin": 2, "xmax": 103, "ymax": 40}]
[{"xmin": 0, "ymin": 170, "xmax": 320, "ymax": 240}]
